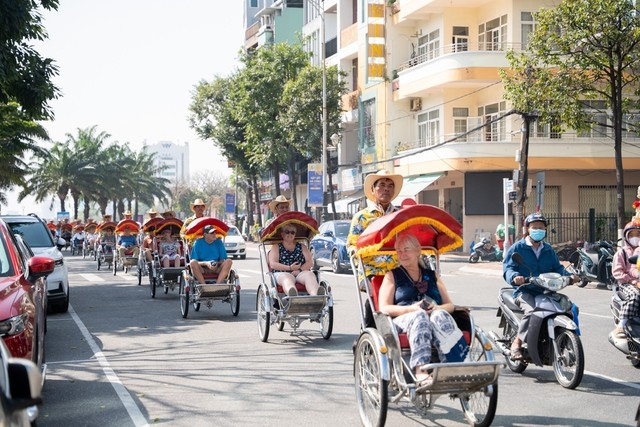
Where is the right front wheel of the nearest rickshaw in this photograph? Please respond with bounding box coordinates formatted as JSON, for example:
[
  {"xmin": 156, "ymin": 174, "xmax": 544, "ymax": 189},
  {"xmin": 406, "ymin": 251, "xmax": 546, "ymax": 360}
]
[{"xmin": 460, "ymin": 331, "xmax": 498, "ymax": 427}]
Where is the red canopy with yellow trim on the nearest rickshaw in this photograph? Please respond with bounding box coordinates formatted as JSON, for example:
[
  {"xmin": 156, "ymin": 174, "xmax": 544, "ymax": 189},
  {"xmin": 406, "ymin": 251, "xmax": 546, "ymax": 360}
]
[{"xmin": 356, "ymin": 205, "xmax": 463, "ymax": 257}]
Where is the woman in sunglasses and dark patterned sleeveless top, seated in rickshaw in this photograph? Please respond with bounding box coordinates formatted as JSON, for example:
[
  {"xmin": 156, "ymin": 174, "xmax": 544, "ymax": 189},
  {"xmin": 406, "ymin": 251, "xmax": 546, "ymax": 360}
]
[{"xmin": 269, "ymin": 225, "xmax": 325, "ymax": 296}]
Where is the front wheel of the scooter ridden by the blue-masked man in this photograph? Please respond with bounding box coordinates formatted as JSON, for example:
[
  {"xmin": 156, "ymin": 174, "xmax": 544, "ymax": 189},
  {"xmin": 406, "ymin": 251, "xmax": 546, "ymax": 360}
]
[{"xmin": 553, "ymin": 329, "xmax": 584, "ymax": 389}]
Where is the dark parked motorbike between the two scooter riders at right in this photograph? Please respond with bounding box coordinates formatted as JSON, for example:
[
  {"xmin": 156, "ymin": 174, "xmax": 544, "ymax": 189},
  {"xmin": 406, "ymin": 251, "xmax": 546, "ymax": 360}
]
[{"xmin": 573, "ymin": 240, "xmax": 616, "ymax": 289}]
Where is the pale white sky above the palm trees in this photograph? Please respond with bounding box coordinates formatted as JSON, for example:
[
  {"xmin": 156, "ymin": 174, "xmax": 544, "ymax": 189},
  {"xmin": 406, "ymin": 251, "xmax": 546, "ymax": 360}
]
[{"xmin": 2, "ymin": 0, "xmax": 244, "ymax": 218}]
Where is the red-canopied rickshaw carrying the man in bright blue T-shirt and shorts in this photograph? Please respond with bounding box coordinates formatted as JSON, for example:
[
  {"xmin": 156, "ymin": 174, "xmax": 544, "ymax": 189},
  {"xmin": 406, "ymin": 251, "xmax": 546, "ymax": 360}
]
[{"xmin": 179, "ymin": 217, "xmax": 240, "ymax": 319}]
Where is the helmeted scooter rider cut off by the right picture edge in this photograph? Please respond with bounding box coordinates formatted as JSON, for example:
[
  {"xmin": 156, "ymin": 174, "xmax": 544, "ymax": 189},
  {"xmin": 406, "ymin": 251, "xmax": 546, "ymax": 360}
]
[{"xmin": 611, "ymin": 219, "xmax": 640, "ymax": 340}]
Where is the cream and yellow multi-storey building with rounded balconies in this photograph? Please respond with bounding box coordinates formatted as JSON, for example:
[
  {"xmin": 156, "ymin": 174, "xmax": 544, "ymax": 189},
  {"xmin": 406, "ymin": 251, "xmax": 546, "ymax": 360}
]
[{"xmin": 249, "ymin": 0, "xmax": 640, "ymax": 246}]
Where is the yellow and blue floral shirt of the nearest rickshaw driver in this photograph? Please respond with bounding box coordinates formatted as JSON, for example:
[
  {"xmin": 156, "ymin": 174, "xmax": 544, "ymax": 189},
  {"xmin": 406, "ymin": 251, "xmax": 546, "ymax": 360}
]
[{"xmin": 347, "ymin": 204, "xmax": 398, "ymax": 279}]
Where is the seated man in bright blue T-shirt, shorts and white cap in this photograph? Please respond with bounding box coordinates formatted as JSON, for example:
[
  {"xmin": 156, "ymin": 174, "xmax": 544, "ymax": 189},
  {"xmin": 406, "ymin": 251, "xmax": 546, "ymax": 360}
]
[{"xmin": 189, "ymin": 225, "xmax": 232, "ymax": 285}]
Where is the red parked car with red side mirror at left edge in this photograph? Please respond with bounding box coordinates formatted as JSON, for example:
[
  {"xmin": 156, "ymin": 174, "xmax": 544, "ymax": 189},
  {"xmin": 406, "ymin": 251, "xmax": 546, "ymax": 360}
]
[{"xmin": 0, "ymin": 219, "xmax": 55, "ymax": 367}]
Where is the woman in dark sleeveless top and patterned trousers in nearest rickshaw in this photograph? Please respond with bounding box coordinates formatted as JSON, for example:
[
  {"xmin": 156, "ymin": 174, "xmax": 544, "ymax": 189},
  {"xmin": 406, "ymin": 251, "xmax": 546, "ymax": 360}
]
[{"xmin": 378, "ymin": 233, "xmax": 469, "ymax": 389}]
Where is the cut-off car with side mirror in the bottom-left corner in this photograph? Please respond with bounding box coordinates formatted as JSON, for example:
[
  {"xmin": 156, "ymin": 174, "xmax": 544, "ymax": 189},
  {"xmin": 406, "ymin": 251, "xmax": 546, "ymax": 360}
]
[{"xmin": 0, "ymin": 340, "xmax": 42, "ymax": 427}]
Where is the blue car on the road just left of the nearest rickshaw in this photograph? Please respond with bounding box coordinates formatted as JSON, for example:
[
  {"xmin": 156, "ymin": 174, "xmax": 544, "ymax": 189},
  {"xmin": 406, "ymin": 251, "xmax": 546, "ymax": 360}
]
[{"xmin": 310, "ymin": 220, "xmax": 351, "ymax": 273}]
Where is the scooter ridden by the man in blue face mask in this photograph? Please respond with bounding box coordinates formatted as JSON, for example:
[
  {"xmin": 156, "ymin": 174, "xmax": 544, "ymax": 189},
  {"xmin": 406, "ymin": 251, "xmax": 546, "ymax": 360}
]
[{"xmin": 489, "ymin": 253, "xmax": 585, "ymax": 389}]
